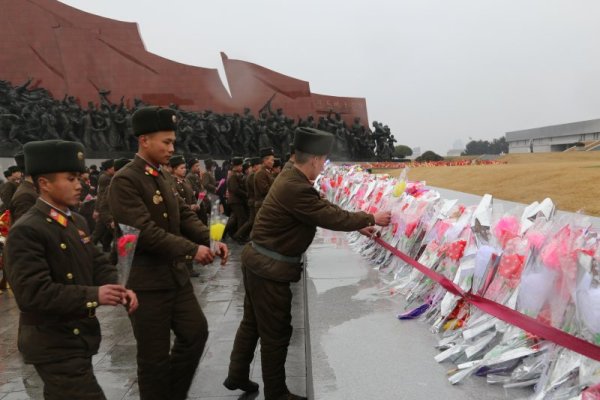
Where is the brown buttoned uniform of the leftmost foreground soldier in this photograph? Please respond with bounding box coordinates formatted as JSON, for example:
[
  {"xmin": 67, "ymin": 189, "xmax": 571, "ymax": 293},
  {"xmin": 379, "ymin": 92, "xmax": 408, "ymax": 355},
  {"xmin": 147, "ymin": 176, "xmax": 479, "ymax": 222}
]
[{"xmin": 5, "ymin": 199, "xmax": 117, "ymax": 399}]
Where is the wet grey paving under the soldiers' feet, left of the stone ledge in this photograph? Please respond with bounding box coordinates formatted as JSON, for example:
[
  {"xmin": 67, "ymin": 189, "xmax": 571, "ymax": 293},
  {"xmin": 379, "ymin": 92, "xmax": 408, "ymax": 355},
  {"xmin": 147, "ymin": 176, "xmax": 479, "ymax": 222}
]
[{"xmin": 0, "ymin": 244, "xmax": 306, "ymax": 400}]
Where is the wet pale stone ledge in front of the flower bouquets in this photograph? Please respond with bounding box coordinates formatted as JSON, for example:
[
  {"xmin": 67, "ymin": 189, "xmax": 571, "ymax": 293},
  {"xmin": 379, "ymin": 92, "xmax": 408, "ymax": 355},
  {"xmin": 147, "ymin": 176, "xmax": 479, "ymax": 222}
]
[{"xmin": 305, "ymin": 230, "xmax": 532, "ymax": 400}]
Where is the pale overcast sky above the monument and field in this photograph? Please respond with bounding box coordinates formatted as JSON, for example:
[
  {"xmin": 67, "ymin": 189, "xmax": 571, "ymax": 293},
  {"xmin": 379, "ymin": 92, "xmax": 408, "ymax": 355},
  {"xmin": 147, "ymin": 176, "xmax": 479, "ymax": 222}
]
[{"xmin": 63, "ymin": 0, "xmax": 600, "ymax": 155}]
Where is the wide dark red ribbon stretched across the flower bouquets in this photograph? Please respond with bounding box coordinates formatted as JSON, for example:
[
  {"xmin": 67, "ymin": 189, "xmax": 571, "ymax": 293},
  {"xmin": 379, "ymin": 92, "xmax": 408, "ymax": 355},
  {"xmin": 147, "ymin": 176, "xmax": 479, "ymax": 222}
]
[{"xmin": 375, "ymin": 238, "xmax": 600, "ymax": 361}]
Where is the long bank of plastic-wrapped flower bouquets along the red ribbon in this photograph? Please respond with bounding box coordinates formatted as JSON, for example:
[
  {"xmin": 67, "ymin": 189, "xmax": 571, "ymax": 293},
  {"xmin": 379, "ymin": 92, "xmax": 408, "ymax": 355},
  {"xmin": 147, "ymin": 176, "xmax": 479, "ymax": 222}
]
[{"xmin": 315, "ymin": 165, "xmax": 600, "ymax": 399}]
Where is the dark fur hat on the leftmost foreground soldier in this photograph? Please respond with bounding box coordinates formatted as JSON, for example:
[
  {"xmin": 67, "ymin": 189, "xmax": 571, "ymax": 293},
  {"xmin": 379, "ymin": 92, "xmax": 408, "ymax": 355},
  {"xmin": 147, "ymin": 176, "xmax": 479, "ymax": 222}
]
[{"xmin": 23, "ymin": 140, "xmax": 85, "ymax": 176}]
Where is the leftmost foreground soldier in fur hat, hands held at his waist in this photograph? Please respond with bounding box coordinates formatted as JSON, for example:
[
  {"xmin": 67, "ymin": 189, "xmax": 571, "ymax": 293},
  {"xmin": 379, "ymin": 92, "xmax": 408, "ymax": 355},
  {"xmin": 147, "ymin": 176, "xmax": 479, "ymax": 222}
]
[{"xmin": 6, "ymin": 140, "xmax": 137, "ymax": 400}]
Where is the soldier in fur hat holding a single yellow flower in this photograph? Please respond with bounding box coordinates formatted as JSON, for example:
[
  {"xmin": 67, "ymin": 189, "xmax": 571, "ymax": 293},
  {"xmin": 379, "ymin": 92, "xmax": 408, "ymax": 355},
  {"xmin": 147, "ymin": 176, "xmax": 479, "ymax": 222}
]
[{"xmin": 109, "ymin": 107, "xmax": 228, "ymax": 400}]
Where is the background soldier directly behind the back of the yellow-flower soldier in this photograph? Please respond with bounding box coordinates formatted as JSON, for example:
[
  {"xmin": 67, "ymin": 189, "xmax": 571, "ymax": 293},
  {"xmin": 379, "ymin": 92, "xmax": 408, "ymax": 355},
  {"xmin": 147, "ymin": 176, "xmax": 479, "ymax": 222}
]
[{"xmin": 92, "ymin": 159, "xmax": 115, "ymax": 252}]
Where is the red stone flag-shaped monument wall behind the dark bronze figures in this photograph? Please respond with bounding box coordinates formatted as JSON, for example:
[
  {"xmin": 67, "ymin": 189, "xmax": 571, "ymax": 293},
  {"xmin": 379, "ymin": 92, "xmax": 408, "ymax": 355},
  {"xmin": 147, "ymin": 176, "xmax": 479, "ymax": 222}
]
[{"xmin": 0, "ymin": 0, "xmax": 368, "ymax": 124}]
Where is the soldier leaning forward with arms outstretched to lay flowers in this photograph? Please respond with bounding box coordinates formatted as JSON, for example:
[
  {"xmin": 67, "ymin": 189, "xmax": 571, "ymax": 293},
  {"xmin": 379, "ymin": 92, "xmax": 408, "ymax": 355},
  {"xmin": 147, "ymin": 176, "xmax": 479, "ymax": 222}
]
[{"xmin": 224, "ymin": 128, "xmax": 390, "ymax": 400}]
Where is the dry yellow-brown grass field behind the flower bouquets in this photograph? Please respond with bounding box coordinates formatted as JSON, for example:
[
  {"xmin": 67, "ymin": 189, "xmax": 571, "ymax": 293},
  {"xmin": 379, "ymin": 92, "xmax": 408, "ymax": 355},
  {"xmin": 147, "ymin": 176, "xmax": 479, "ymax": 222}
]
[{"xmin": 386, "ymin": 151, "xmax": 600, "ymax": 216}]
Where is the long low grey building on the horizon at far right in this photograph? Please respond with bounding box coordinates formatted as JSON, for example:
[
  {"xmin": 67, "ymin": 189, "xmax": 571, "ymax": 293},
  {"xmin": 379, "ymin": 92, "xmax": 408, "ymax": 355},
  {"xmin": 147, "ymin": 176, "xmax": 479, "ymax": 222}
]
[{"xmin": 506, "ymin": 119, "xmax": 600, "ymax": 153}]
